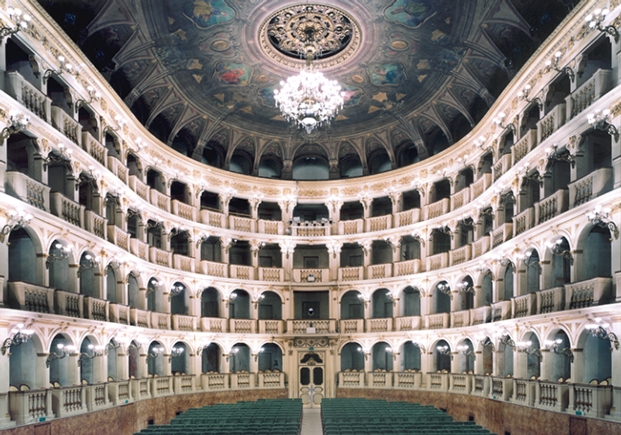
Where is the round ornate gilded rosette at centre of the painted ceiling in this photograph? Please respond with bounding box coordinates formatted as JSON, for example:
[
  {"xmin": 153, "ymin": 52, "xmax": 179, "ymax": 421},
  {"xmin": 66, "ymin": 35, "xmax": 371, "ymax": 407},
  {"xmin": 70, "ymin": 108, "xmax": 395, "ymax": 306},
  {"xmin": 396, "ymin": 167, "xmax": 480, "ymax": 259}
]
[{"xmin": 259, "ymin": 4, "xmax": 361, "ymax": 70}]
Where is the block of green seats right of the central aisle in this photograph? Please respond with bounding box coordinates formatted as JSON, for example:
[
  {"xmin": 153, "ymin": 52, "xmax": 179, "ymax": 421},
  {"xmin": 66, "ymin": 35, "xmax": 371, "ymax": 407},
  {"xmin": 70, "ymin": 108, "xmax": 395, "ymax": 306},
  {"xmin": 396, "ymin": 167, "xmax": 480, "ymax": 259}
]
[{"xmin": 321, "ymin": 399, "xmax": 493, "ymax": 435}]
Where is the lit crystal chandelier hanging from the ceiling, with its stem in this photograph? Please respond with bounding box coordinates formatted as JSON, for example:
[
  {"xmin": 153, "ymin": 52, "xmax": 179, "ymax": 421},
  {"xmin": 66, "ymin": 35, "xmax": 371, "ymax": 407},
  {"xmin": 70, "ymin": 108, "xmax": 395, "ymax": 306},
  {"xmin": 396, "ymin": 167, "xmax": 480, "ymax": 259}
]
[{"xmin": 274, "ymin": 28, "xmax": 344, "ymax": 134}]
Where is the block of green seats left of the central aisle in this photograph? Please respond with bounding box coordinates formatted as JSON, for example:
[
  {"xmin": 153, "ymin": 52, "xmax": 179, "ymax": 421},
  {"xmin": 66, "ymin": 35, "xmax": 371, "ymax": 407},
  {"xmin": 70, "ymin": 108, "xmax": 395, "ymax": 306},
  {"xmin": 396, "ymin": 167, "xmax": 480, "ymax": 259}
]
[{"xmin": 134, "ymin": 399, "xmax": 302, "ymax": 435}]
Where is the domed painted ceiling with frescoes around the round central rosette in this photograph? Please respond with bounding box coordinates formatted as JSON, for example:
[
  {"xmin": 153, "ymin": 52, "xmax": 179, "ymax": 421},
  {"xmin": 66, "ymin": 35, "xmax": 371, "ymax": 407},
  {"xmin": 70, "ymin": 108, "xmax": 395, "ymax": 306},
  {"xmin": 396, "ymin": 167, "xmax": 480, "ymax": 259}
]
[{"xmin": 39, "ymin": 0, "xmax": 568, "ymax": 161}]
